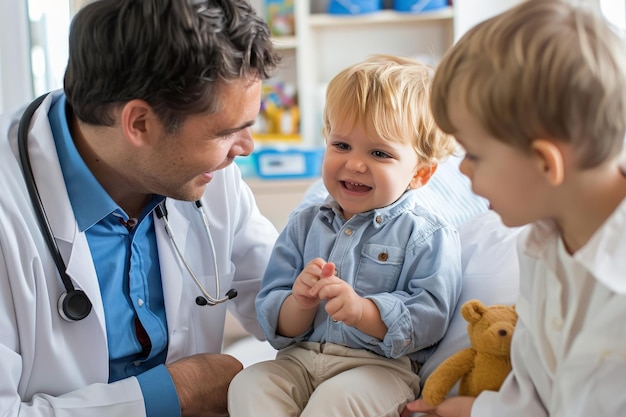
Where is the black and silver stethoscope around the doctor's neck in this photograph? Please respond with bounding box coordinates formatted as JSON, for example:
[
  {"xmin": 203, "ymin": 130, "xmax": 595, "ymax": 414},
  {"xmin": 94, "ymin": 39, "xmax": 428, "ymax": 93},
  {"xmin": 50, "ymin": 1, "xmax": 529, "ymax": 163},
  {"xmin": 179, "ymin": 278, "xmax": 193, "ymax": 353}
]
[{"xmin": 17, "ymin": 94, "xmax": 237, "ymax": 321}]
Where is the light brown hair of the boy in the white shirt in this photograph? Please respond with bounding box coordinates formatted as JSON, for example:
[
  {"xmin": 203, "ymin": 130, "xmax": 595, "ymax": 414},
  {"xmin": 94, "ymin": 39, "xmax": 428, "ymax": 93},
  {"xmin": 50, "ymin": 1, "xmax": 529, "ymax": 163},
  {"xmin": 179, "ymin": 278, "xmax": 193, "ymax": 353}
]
[{"xmin": 431, "ymin": 0, "xmax": 626, "ymax": 168}]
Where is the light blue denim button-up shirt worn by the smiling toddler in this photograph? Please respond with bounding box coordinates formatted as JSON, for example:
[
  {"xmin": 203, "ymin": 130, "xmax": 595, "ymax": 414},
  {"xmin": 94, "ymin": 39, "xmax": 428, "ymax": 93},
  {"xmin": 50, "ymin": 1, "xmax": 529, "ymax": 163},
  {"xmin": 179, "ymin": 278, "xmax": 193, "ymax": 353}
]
[{"xmin": 256, "ymin": 191, "xmax": 461, "ymax": 363}]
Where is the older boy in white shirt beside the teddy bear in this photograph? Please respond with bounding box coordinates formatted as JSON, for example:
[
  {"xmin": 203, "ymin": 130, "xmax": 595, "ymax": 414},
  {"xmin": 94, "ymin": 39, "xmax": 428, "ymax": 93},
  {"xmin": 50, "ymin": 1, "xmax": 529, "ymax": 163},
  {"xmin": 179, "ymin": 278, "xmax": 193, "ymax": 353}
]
[{"xmin": 403, "ymin": 0, "xmax": 626, "ymax": 417}]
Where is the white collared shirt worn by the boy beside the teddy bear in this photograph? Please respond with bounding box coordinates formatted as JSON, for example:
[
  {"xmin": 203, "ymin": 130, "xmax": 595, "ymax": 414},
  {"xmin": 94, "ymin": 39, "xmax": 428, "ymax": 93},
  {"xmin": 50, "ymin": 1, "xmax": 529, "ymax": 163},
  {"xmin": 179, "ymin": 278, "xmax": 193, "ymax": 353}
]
[{"xmin": 471, "ymin": 187, "xmax": 626, "ymax": 417}]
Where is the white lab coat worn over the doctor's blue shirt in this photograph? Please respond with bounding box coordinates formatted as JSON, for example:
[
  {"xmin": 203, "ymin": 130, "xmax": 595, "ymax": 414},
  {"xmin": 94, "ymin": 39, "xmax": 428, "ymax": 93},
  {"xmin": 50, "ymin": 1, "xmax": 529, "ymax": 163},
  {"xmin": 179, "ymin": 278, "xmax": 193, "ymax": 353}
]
[{"xmin": 0, "ymin": 93, "xmax": 277, "ymax": 417}]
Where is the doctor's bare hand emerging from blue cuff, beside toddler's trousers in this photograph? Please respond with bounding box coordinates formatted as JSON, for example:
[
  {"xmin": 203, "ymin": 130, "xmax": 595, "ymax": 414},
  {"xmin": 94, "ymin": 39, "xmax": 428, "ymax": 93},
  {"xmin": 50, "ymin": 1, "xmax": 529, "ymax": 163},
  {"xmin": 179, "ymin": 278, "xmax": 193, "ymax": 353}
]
[{"xmin": 167, "ymin": 353, "xmax": 243, "ymax": 417}]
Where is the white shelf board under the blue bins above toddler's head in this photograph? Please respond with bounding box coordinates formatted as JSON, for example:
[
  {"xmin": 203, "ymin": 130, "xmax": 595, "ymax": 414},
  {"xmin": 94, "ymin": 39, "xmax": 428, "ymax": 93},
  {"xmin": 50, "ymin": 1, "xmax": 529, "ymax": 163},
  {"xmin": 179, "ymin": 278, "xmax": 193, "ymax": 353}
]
[{"xmin": 309, "ymin": 7, "xmax": 454, "ymax": 28}]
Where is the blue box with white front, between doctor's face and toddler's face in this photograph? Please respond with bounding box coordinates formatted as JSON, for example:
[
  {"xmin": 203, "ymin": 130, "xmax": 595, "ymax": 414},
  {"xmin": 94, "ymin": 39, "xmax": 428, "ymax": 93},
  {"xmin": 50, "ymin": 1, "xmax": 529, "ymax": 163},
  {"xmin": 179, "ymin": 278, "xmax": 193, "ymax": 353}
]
[{"xmin": 252, "ymin": 148, "xmax": 324, "ymax": 179}]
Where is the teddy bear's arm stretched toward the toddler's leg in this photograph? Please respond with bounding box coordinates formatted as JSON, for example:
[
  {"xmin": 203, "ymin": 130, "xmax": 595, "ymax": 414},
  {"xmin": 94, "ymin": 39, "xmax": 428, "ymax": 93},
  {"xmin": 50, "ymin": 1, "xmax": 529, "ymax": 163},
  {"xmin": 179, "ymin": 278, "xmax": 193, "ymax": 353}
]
[{"xmin": 422, "ymin": 348, "xmax": 476, "ymax": 405}]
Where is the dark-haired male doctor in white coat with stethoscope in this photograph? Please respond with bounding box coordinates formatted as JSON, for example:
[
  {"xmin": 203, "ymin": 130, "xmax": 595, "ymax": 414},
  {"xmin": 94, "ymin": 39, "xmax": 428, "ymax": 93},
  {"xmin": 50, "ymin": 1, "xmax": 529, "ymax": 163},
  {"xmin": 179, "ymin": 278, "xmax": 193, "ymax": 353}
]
[{"xmin": 0, "ymin": 0, "xmax": 279, "ymax": 417}]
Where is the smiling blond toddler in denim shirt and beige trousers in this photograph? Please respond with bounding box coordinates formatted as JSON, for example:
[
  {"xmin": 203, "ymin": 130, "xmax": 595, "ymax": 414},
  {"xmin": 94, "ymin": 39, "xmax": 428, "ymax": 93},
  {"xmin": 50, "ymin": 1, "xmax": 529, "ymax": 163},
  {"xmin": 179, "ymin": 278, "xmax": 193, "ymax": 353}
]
[{"xmin": 229, "ymin": 55, "xmax": 461, "ymax": 417}]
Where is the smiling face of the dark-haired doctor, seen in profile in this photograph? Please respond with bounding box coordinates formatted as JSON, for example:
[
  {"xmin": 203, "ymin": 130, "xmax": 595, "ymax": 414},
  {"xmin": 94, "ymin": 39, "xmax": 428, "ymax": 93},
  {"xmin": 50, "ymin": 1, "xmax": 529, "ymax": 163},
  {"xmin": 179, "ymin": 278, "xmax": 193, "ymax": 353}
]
[{"xmin": 144, "ymin": 79, "xmax": 261, "ymax": 201}]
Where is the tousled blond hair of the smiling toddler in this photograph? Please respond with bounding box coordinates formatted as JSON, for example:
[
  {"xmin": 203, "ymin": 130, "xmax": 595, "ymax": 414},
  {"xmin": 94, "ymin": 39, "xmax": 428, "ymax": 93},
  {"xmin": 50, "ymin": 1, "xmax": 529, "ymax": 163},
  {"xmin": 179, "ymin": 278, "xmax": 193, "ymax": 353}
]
[{"xmin": 323, "ymin": 55, "xmax": 456, "ymax": 164}]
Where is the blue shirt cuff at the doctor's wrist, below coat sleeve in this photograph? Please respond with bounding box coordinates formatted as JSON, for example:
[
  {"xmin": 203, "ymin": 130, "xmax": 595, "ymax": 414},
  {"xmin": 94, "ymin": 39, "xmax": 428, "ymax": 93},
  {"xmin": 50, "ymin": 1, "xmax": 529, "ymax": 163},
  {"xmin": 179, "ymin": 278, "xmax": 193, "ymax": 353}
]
[{"xmin": 137, "ymin": 365, "xmax": 181, "ymax": 417}]
